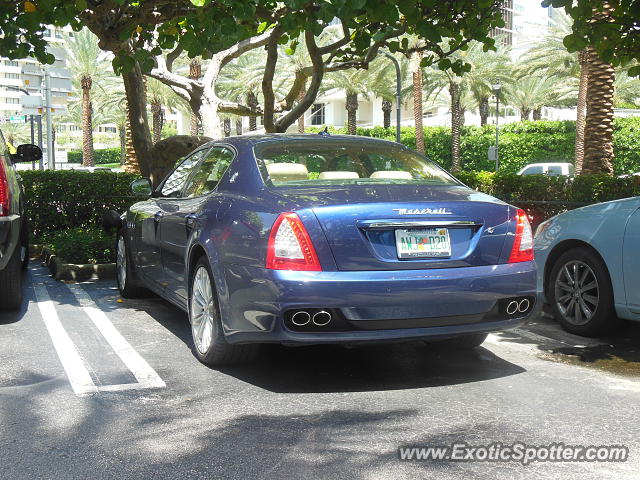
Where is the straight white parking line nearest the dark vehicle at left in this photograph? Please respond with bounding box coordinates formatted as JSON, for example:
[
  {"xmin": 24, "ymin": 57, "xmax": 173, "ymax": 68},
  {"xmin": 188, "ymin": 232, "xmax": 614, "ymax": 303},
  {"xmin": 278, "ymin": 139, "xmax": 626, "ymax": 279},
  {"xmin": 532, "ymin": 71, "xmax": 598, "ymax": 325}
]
[{"xmin": 33, "ymin": 284, "xmax": 98, "ymax": 395}]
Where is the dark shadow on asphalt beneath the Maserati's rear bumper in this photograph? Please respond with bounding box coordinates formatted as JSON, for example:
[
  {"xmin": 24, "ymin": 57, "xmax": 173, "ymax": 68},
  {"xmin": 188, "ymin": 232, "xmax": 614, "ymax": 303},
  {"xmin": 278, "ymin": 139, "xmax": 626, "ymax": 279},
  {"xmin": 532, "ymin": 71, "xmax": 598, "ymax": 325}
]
[{"xmin": 218, "ymin": 342, "xmax": 525, "ymax": 393}]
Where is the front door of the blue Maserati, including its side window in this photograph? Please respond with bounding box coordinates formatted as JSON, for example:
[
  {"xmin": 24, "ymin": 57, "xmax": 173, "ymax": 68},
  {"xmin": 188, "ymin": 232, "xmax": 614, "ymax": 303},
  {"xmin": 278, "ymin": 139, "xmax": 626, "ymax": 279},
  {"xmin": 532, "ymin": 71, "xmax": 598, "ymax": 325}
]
[{"xmin": 132, "ymin": 150, "xmax": 205, "ymax": 288}]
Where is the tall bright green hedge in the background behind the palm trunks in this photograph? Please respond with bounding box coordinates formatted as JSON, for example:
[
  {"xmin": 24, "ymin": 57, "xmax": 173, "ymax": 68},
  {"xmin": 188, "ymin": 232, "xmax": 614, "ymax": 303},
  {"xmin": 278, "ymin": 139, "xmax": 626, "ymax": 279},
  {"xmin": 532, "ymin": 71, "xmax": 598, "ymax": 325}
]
[{"xmin": 308, "ymin": 117, "xmax": 640, "ymax": 174}]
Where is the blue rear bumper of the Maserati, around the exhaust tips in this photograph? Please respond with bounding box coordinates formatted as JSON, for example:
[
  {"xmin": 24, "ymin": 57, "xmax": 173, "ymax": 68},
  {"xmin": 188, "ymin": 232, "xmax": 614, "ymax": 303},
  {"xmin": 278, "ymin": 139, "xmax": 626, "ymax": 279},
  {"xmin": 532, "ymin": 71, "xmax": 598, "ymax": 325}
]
[{"xmin": 220, "ymin": 262, "xmax": 536, "ymax": 344}]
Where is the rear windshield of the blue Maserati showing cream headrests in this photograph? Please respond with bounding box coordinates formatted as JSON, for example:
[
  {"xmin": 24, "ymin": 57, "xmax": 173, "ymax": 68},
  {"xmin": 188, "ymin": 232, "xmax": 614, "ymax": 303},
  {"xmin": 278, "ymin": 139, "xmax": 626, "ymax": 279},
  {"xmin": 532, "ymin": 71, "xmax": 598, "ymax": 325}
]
[{"xmin": 254, "ymin": 139, "xmax": 459, "ymax": 187}]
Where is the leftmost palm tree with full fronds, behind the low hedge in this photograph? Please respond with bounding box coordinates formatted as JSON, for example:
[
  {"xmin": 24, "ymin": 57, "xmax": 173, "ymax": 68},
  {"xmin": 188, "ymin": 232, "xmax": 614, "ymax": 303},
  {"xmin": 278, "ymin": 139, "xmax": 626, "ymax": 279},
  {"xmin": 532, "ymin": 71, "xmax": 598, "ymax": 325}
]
[{"xmin": 66, "ymin": 28, "xmax": 111, "ymax": 166}]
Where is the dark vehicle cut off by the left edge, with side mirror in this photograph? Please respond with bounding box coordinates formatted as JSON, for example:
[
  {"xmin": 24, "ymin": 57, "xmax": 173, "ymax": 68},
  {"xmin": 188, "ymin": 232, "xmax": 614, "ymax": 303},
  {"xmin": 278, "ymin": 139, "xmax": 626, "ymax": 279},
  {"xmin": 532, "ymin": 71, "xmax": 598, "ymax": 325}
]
[{"xmin": 0, "ymin": 131, "xmax": 42, "ymax": 310}]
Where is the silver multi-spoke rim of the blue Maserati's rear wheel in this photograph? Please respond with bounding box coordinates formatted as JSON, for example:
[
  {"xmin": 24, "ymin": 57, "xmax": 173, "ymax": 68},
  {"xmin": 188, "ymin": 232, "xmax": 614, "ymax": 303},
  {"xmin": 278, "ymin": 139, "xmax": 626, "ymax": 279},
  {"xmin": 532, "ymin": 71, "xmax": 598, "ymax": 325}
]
[{"xmin": 190, "ymin": 266, "xmax": 217, "ymax": 354}]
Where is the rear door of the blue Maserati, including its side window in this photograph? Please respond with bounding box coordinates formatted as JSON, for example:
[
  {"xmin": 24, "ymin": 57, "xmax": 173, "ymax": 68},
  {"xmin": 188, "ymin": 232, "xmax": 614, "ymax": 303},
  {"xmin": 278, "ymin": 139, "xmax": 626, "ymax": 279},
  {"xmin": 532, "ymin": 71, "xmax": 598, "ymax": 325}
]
[{"xmin": 160, "ymin": 145, "xmax": 235, "ymax": 300}]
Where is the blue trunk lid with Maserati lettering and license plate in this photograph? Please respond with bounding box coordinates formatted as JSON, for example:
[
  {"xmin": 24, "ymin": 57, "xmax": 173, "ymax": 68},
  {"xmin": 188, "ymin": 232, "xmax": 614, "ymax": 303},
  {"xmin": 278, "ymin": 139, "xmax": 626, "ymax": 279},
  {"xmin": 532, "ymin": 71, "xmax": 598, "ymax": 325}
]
[{"xmin": 278, "ymin": 185, "xmax": 512, "ymax": 271}]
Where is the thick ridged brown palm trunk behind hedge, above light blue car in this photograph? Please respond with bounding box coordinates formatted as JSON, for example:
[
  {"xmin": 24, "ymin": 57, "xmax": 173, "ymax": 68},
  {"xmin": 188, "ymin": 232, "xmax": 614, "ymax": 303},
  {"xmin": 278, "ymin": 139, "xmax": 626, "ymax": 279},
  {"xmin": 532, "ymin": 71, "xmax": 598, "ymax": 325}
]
[{"xmin": 582, "ymin": 47, "xmax": 616, "ymax": 174}]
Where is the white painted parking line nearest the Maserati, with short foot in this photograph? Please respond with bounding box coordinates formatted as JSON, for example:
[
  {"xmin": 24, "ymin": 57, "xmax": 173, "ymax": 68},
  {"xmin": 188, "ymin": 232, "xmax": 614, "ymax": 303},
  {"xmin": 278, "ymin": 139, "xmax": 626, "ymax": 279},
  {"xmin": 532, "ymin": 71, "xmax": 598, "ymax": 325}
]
[{"xmin": 66, "ymin": 284, "xmax": 166, "ymax": 391}]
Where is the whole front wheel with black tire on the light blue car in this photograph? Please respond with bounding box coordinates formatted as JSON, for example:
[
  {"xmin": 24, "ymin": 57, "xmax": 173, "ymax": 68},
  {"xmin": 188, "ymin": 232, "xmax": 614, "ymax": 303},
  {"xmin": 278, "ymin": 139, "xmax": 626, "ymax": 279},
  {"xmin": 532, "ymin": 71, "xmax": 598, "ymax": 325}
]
[{"xmin": 547, "ymin": 248, "xmax": 619, "ymax": 337}]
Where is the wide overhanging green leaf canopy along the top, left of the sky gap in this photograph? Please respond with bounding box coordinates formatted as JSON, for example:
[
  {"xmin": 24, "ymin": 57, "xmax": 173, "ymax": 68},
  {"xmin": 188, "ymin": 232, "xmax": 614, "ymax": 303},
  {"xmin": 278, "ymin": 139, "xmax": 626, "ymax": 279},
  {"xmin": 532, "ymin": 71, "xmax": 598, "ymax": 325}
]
[{"xmin": 8, "ymin": 0, "xmax": 503, "ymax": 72}]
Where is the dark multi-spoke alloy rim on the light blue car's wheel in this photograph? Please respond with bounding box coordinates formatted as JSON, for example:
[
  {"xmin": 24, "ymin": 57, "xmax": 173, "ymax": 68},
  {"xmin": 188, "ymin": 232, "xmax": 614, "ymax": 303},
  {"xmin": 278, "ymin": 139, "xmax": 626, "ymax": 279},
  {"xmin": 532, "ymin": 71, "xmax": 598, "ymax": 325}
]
[{"xmin": 554, "ymin": 260, "xmax": 600, "ymax": 325}]
